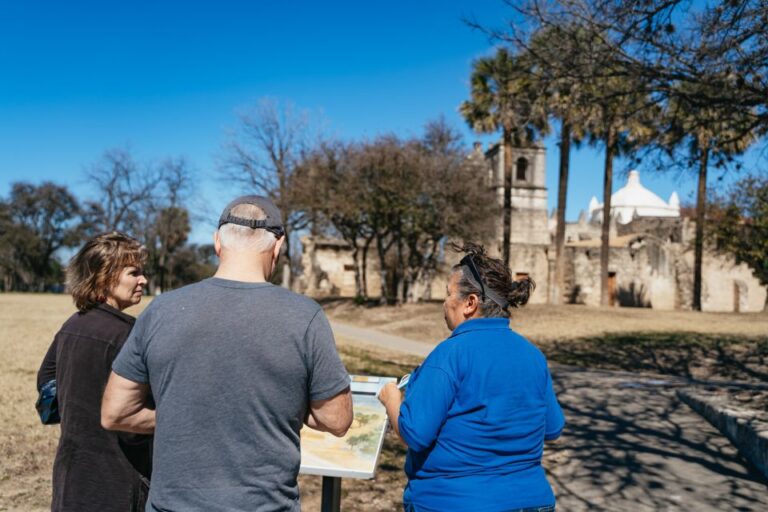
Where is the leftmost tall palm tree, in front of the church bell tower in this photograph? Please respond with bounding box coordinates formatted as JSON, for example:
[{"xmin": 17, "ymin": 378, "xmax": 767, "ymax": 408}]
[{"xmin": 459, "ymin": 48, "xmax": 548, "ymax": 266}]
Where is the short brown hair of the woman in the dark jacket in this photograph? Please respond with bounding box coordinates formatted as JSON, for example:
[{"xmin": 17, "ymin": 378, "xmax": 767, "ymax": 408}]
[{"xmin": 67, "ymin": 231, "xmax": 147, "ymax": 311}]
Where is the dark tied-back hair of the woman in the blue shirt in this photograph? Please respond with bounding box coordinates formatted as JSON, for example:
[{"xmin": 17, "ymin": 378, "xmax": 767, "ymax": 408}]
[{"xmin": 451, "ymin": 242, "xmax": 536, "ymax": 318}]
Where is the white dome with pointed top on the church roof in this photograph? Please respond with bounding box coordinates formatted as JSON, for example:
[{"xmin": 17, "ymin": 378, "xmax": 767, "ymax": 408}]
[{"xmin": 589, "ymin": 171, "xmax": 680, "ymax": 224}]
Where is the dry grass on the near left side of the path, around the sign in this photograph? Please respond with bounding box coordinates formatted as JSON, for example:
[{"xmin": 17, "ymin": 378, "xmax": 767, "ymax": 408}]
[{"xmin": 0, "ymin": 294, "xmax": 418, "ymax": 512}]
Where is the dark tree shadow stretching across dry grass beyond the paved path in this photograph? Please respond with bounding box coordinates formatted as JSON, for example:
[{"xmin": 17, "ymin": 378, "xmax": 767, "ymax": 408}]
[{"xmin": 540, "ymin": 332, "xmax": 768, "ymax": 382}]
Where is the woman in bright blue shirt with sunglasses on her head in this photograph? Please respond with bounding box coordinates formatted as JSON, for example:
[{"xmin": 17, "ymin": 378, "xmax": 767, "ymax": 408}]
[{"xmin": 379, "ymin": 244, "xmax": 565, "ymax": 512}]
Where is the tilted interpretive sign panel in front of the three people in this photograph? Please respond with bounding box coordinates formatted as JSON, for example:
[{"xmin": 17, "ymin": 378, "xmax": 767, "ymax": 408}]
[{"xmin": 300, "ymin": 375, "xmax": 397, "ymax": 478}]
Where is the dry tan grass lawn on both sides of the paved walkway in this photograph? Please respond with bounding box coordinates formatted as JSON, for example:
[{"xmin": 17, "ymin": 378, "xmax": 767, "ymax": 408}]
[{"xmin": 0, "ymin": 294, "xmax": 768, "ymax": 512}]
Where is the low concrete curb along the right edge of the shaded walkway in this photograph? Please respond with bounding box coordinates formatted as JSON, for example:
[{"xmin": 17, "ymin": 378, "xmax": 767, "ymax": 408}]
[{"xmin": 677, "ymin": 388, "xmax": 768, "ymax": 479}]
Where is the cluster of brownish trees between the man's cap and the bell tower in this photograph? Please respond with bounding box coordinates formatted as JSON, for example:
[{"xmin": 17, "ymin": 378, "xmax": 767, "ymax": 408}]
[{"xmin": 220, "ymin": 99, "xmax": 498, "ymax": 304}]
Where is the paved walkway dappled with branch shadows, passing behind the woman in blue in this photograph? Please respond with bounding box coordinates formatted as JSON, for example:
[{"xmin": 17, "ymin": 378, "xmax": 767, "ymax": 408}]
[{"xmin": 332, "ymin": 322, "xmax": 768, "ymax": 512}]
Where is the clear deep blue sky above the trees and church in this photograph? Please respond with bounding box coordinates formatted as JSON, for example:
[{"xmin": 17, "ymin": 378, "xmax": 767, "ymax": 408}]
[{"xmin": 0, "ymin": 0, "xmax": 760, "ymax": 242}]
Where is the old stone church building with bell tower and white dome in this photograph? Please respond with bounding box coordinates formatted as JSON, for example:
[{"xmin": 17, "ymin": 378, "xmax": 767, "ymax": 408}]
[{"xmin": 299, "ymin": 144, "xmax": 766, "ymax": 312}]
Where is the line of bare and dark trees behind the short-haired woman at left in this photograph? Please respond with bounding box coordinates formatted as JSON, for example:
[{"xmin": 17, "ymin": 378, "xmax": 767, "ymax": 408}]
[{"xmin": 0, "ymin": 149, "xmax": 214, "ymax": 293}]
